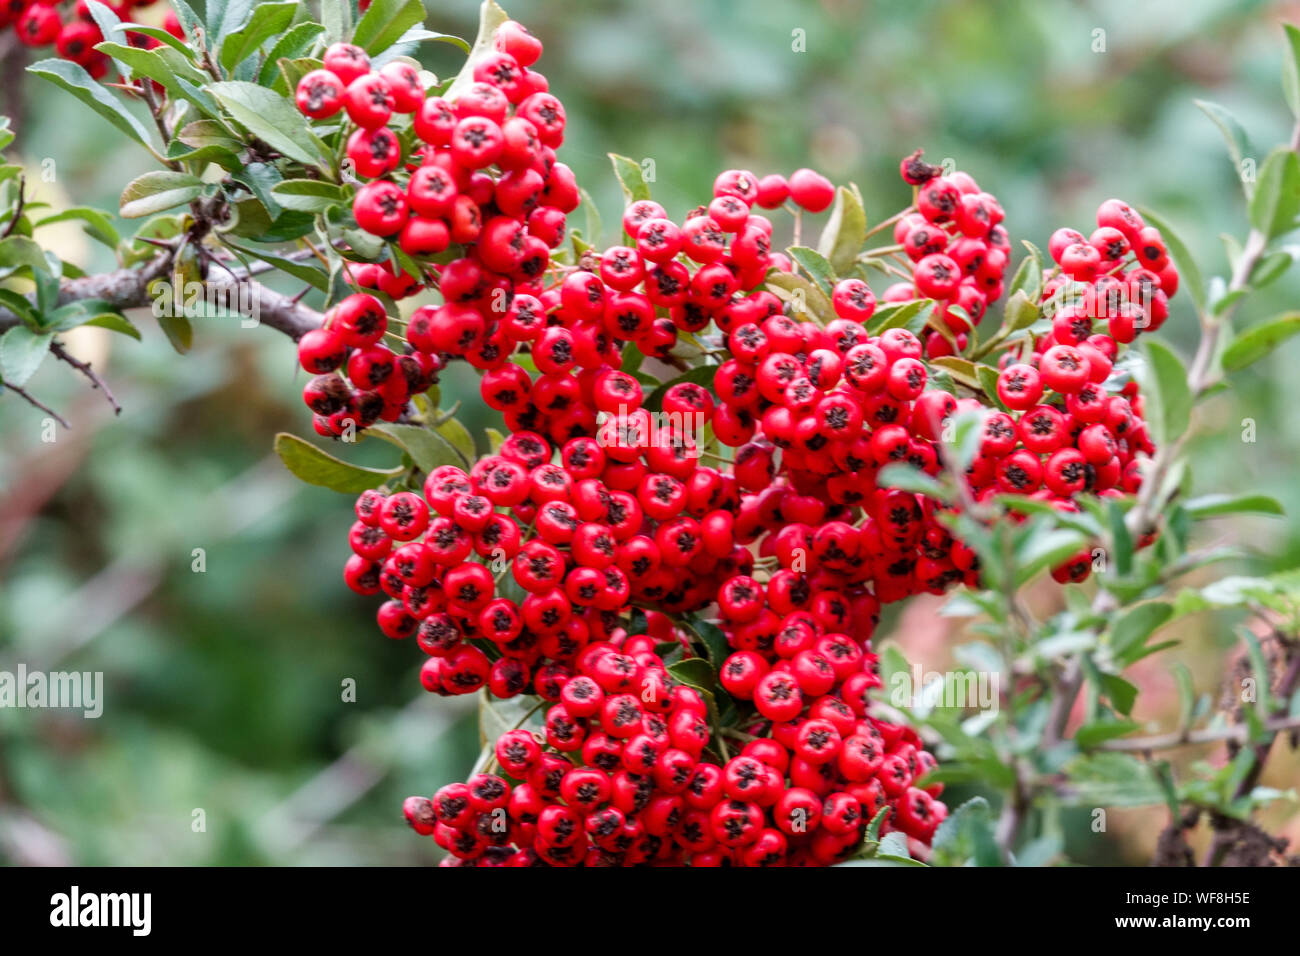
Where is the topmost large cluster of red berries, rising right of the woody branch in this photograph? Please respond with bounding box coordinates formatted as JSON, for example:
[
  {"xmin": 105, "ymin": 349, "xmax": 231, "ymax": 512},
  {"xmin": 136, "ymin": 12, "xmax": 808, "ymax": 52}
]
[{"xmin": 295, "ymin": 21, "xmax": 580, "ymax": 306}]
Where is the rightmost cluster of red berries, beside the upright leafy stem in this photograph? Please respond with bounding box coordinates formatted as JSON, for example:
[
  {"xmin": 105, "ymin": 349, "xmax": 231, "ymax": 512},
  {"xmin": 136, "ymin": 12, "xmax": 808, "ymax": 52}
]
[{"xmin": 967, "ymin": 199, "xmax": 1178, "ymax": 583}]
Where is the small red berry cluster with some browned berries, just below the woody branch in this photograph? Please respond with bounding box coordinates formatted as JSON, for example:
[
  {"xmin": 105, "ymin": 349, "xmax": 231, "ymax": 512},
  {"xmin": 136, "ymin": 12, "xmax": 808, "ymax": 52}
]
[{"xmin": 298, "ymin": 293, "xmax": 442, "ymax": 438}]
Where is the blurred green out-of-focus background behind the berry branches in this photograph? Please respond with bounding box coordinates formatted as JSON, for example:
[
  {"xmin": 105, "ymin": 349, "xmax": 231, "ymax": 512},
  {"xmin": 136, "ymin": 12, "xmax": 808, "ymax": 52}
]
[{"xmin": 0, "ymin": 0, "xmax": 1300, "ymax": 864}]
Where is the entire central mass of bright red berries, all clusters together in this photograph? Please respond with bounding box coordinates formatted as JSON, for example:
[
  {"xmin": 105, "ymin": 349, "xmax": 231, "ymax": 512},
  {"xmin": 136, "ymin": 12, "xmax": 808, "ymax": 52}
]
[{"xmin": 296, "ymin": 16, "xmax": 1178, "ymax": 865}]
